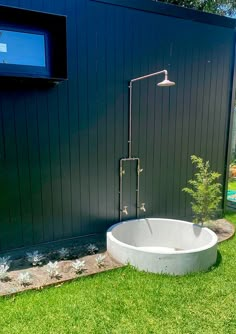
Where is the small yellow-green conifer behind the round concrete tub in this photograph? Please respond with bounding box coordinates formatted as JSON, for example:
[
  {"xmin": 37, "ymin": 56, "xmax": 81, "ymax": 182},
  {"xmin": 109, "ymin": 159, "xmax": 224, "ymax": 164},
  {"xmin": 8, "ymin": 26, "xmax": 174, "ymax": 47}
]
[{"xmin": 182, "ymin": 155, "xmax": 222, "ymax": 224}]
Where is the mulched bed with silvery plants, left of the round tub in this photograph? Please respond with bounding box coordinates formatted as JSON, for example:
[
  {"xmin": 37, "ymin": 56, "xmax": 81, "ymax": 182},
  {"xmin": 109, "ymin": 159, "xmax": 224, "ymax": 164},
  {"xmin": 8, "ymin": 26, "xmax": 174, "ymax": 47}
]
[{"xmin": 0, "ymin": 241, "xmax": 122, "ymax": 296}]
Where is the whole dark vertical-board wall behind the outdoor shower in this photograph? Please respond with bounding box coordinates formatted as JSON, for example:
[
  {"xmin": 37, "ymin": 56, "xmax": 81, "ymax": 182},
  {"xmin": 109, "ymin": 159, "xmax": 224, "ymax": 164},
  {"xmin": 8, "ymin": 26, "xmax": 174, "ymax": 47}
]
[{"xmin": 0, "ymin": 0, "xmax": 234, "ymax": 251}]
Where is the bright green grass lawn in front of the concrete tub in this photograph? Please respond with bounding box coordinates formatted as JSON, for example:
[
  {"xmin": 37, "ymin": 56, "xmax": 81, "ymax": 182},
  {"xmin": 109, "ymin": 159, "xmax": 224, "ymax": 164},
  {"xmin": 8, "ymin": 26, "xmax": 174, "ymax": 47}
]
[{"xmin": 0, "ymin": 213, "xmax": 236, "ymax": 334}]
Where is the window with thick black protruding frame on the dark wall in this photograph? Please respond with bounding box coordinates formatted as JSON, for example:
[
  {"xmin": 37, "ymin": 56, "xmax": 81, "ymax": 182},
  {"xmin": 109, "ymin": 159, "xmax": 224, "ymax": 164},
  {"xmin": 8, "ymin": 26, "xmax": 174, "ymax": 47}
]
[{"xmin": 0, "ymin": 6, "xmax": 67, "ymax": 82}]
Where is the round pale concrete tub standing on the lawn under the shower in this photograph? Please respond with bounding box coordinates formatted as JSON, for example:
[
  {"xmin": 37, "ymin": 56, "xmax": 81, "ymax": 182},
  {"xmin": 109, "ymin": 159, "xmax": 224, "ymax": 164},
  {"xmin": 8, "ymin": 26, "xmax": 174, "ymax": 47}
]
[{"xmin": 107, "ymin": 218, "xmax": 217, "ymax": 275}]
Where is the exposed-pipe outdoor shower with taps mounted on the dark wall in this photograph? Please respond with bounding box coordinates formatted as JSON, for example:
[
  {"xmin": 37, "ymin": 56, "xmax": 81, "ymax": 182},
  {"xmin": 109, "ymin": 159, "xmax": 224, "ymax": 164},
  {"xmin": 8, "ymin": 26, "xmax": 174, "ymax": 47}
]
[{"xmin": 119, "ymin": 70, "xmax": 175, "ymax": 221}]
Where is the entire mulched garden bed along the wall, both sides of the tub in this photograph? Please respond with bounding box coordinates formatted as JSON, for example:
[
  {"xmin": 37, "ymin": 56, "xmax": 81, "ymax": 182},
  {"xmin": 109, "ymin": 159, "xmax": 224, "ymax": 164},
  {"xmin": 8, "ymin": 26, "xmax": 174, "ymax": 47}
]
[{"xmin": 0, "ymin": 219, "xmax": 235, "ymax": 296}]
